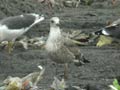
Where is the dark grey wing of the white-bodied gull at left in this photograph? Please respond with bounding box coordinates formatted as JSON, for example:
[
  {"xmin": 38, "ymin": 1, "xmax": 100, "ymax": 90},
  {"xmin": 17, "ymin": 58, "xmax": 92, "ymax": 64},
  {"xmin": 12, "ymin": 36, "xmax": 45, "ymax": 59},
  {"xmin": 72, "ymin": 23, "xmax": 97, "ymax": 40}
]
[{"xmin": 0, "ymin": 14, "xmax": 35, "ymax": 29}]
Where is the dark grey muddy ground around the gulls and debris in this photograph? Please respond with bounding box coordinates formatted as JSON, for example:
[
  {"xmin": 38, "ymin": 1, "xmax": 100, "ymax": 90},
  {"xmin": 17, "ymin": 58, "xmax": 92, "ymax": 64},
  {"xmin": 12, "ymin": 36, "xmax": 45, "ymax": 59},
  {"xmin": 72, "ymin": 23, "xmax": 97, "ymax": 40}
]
[{"xmin": 0, "ymin": 0, "xmax": 120, "ymax": 90}]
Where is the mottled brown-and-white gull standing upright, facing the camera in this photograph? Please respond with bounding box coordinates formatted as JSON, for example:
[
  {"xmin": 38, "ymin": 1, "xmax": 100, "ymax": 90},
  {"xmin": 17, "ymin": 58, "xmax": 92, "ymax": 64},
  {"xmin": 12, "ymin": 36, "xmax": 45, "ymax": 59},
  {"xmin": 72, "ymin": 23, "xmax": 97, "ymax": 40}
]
[{"xmin": 45, "ymin": 17, "xmax": 88, "ymax": 79}]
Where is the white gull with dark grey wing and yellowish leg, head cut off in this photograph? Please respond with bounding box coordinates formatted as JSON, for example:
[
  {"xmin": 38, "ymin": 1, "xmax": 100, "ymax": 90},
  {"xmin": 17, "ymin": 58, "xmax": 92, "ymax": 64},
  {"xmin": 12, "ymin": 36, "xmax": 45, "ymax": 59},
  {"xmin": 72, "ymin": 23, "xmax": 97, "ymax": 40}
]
[{"xmin": 0, "ymin": 13, "xmax": 44, "ymax": 53}]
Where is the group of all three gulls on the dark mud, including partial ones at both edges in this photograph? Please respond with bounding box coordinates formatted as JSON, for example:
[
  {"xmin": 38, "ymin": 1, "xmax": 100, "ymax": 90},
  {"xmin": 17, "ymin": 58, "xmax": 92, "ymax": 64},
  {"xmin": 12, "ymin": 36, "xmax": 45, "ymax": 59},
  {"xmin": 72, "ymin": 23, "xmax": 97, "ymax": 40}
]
[{"xmin": 0, "ymin": 13, "xmax": 120, "ymax": 78}]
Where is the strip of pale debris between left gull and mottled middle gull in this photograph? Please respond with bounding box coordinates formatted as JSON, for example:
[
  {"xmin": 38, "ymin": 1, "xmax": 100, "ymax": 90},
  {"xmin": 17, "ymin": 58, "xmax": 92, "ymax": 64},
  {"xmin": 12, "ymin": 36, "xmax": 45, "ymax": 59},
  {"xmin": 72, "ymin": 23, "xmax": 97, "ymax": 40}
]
[{"xmin": 0, "ymin": 36, "xmax": 46, "ymax": 50}]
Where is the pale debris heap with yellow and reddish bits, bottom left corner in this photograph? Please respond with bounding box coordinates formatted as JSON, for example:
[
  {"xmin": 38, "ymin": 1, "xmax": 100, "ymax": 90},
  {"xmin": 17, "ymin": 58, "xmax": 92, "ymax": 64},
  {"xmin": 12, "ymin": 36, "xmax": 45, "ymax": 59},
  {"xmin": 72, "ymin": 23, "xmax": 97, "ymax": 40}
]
[{"xmin": 0, "ymin": 66, "xmax": 45, "ymax": 90}]
